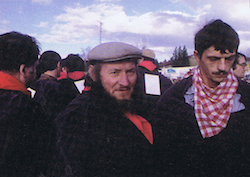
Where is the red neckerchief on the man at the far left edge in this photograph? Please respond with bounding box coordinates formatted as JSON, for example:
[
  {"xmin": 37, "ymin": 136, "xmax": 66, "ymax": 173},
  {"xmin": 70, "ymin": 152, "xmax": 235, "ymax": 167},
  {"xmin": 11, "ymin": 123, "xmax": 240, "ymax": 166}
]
[{"xmin": 0, "ymin": 71, "xmax": 31, "ymax": 96}]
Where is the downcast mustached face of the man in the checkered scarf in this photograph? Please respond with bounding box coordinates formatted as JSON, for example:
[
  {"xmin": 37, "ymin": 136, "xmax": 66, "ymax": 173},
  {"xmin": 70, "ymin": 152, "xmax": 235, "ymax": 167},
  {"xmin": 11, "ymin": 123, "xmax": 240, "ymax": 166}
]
[{"xmin": 195, "ymin": 46, "xmax": 236, "ymax": 88}]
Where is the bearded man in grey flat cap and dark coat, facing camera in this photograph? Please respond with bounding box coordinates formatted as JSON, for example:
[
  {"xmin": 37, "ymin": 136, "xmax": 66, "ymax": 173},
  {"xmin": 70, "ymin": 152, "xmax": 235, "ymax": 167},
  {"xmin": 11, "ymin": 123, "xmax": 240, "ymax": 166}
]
[{"xmin": 53, "ymin": 42, "xmax": 153, "ymax": 176}]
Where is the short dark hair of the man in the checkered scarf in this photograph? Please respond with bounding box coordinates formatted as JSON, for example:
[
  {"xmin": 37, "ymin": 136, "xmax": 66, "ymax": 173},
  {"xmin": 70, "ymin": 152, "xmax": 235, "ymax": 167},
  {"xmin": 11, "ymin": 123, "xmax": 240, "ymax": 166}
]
[{"xmin": 195, "ymin": 19, "xmax": 239, "ymax": 57}]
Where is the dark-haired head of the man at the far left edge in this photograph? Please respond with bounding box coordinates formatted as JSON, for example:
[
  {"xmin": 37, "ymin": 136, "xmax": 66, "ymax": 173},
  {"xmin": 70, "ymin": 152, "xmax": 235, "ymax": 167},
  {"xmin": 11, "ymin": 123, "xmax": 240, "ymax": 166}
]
[{"xmin": 0, "ymin": 32, "xmax": 40, "ymax": 85}]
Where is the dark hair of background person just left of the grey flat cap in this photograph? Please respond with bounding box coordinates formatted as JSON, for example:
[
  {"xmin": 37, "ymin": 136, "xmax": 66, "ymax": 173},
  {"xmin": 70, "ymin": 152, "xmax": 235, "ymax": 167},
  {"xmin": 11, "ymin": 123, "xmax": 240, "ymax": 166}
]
[{"xmin": 62, "ymin": 54, "xmax": 85, "ymax": 72}]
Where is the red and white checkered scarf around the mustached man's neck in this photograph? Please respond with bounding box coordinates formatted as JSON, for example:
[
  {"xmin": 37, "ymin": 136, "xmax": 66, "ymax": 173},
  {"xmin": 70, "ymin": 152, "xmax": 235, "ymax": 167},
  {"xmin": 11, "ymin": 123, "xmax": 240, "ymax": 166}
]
[{"xmin": 193, "ymin": 68, "xmax": 238, "ymax": 138}]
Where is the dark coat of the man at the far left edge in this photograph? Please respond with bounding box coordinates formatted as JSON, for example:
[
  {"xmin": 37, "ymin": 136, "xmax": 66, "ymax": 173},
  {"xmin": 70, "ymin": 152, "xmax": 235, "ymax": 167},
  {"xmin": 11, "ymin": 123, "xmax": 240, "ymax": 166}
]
[{"xmin": 0, "ymin": 90, "xmax": 48, "ymax": 177}]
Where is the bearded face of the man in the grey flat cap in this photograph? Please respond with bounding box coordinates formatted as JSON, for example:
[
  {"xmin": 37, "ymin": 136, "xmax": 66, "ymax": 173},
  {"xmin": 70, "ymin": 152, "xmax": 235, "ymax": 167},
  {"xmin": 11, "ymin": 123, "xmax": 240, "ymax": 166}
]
[{"xmin": 100, "ymin": 61, "xmax": 137, "ymax": 100}]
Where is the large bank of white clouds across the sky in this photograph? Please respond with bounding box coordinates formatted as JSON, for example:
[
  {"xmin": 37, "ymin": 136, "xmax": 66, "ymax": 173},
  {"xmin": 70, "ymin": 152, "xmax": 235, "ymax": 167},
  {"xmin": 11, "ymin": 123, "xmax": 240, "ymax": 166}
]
[{"xmin": 33, "ymin": 0, "xmax": 250, "ymax": 61}]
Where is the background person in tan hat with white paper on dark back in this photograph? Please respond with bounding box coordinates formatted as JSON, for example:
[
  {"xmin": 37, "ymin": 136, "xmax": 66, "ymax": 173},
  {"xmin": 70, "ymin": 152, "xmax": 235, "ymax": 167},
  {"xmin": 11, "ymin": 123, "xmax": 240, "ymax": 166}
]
[{"xmin": 137, "ymin": 49, "xmax": 172, "ymax": 115}]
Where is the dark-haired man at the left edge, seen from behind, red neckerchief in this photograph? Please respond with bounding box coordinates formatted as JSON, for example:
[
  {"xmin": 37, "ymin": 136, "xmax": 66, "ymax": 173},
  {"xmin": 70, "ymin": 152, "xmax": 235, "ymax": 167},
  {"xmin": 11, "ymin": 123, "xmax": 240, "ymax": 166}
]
[{"xmin": 0, "ymin": 32, "xmax": 48, "ymax": 177}]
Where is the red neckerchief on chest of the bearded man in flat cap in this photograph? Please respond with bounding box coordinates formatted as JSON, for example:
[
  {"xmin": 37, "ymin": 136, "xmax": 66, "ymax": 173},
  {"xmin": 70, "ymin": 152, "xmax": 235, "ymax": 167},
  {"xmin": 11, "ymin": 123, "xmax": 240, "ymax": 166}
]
[{"xmin": 125, "ymin": 113, "xmax": 153, "ymax": 144}]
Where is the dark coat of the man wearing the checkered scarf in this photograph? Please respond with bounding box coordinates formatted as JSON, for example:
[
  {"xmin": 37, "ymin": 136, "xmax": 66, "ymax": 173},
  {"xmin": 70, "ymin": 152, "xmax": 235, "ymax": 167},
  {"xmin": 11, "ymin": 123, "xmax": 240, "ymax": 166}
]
[{"xmin": 153, "ymin": 76, "xmax": 250, "ymax": 177}]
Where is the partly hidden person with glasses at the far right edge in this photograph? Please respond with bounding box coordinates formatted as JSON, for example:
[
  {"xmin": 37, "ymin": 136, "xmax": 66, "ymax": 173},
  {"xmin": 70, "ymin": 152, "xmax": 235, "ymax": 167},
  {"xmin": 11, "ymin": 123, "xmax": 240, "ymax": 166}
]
[{"xmin": 233, "ymin": 53, "xmax": 247, "ymax": 79}]
